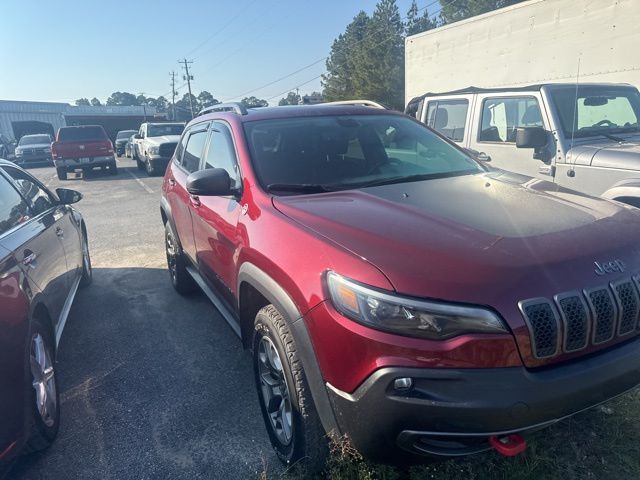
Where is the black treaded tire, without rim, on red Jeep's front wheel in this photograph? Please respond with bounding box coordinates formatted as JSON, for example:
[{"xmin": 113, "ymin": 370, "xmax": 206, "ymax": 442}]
[{"xmin": 253, "ymin": 305, "xmax": 329, "ymax": 475}]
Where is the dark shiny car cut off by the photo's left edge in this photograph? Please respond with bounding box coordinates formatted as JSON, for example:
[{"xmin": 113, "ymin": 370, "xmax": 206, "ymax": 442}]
[{"xmin": 0, "ymin": 160, "xmax": 91, "ymax": 477}]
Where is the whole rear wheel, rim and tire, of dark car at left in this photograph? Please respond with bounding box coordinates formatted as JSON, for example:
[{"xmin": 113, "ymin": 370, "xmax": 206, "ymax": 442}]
[{"xmin": 26, "ymin": 319, "xmax": 60, "ymax": 451}]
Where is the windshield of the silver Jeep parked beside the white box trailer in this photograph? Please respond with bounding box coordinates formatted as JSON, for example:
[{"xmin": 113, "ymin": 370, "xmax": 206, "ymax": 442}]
[{"xmin": 551, "ymin": 86, "xmax": 640, "ymax": 138}]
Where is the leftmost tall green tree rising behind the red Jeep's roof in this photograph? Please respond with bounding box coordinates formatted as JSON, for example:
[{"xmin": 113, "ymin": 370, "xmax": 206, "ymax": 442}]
[{"xmin": 322, "ymin": 11, "xmax": 371, "ymax": 101}]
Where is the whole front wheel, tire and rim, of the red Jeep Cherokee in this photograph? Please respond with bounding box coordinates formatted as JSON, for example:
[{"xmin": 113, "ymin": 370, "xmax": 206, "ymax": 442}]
[{"xmin": 253, "ymin": 305, "xmax": 328, "ymax": 474}]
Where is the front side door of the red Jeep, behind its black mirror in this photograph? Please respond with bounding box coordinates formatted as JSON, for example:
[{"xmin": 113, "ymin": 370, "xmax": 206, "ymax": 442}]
[{"xmin": 190, "ymin": 122, "xmax": 242, "ymax": 311}]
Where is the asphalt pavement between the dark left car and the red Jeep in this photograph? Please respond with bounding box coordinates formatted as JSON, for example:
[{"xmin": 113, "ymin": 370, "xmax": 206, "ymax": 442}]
[{"xmin": 8, "ymin": 158, "xmax": 280, "ymax": 480}]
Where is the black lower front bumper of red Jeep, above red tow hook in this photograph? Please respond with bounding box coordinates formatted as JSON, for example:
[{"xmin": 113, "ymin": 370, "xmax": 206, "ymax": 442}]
[{"xmin": 327, "ymin": 339, "xmax": 640, "ymax": 462}]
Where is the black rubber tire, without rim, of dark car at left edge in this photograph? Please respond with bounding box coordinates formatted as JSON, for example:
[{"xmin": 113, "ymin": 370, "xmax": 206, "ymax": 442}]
[{"xmin": 25, "ymin": 319, "xmax": 60, "ymax": 453}]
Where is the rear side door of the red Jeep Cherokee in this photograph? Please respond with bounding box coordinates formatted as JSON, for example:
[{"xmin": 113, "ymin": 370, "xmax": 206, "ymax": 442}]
[{"xmin": 165, "ymin": 122, "xmax": 209, "ymax": 265}]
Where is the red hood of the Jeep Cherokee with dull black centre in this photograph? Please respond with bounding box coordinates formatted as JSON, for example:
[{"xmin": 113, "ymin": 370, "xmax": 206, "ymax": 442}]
[{"xmin": 273, "ymin": 171, "xmax": 640, "ymax": 327}]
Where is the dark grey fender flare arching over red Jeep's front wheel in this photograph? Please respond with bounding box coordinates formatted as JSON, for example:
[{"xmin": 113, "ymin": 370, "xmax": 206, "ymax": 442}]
[{"xmin": 237, "ymin": 262, "xmax": 340, "ymax": 433}]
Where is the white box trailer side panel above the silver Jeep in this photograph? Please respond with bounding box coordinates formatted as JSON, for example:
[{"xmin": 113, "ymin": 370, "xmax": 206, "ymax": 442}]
[{"xmin": 405, "ymin": 0, "xmax": 640, "ymax": 103}]
